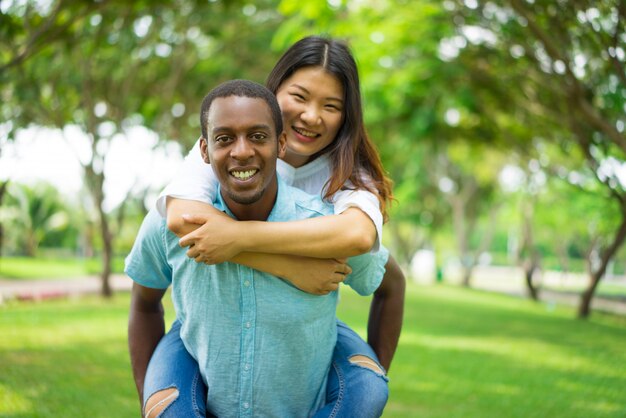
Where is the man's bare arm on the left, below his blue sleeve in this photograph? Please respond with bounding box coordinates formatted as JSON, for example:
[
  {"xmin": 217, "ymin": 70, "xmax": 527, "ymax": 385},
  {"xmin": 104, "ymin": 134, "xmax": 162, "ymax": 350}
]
[{"xmin": 128, "ymin": 283, "xmax": 165, "ymax": 409}]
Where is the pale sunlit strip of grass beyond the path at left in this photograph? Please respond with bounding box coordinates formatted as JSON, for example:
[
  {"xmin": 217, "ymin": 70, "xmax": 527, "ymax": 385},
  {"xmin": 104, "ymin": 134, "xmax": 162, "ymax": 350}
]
[{"xmin": 0, "ymin": 257, "xmax": 124, "ymax": 280}]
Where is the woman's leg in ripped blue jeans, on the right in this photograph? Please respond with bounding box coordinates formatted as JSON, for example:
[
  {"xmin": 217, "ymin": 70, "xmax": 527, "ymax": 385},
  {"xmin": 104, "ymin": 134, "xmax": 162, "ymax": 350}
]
[{"xmin": 314, "ymin": 321, "xmax": 389, "ymax": 418}]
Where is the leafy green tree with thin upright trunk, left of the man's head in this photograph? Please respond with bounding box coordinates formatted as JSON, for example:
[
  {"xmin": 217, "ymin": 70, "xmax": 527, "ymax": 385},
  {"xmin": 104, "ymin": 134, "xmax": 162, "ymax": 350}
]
[{"xmin": 0, "ymin": 0, "xmax": 277, "ymax": 296}]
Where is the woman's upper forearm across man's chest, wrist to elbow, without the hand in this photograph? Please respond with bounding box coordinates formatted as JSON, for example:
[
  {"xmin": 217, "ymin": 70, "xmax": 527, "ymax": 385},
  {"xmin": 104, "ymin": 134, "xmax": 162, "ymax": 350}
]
[{"xmin": 241, "ymin": 208, "xmax": 376, "ymax": 258}]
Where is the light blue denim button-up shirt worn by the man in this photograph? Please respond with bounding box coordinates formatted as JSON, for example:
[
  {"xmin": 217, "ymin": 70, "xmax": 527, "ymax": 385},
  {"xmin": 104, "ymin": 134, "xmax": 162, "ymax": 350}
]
[{"xmin": 126, "ymin": 180, "xmax": 388, "ymax": 418}]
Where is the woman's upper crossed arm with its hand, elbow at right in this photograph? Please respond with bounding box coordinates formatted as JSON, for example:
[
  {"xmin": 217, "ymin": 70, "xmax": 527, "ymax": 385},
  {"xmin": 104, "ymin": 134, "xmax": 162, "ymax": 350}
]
[{"xmin": 178, "ymin": 208, "xmax": 377, "ymax": 264}]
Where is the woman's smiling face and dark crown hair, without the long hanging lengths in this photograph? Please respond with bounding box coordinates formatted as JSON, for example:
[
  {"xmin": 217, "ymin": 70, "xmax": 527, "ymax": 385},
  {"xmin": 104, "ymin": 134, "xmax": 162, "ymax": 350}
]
[{"xmin": 266, "ymin": 36, "xmax": 363, "ymax": 165}]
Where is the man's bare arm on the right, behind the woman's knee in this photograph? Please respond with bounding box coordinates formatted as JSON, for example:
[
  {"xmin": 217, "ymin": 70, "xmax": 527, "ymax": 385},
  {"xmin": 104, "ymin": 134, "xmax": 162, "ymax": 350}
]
[{"xmin": 367, "ymin": 256, "xmax": 406, "ymax": 370}]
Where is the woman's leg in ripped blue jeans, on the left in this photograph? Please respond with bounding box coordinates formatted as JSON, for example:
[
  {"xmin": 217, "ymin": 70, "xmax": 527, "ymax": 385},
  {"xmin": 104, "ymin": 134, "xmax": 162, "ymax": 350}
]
[{"xmin": 143, "ymin": 321, "xmax": 207, "ymax": 418}]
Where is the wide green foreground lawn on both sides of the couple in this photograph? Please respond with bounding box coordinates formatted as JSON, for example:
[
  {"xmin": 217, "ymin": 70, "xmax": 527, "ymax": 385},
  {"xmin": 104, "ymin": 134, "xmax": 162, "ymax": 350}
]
[{"xmin": 0, "ymin": 285, "xmax": 626, "ymax": 418}]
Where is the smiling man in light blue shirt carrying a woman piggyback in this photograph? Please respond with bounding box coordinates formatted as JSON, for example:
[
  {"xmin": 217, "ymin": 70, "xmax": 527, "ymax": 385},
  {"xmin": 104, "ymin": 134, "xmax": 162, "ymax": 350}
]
[{"xmin": 127, "ymin": 80, "xmax": 380, "ymax": 417}]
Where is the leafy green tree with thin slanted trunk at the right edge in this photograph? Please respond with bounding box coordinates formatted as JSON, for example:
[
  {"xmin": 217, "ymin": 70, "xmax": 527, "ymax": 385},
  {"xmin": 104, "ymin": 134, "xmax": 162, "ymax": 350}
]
[{"xmin": 452, "ymin": 0, "xmax": 626, "ymax": 318}]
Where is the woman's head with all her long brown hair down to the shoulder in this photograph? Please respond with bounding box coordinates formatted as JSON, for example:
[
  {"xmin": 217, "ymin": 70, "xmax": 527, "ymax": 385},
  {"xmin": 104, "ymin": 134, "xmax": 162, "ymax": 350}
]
[{"xmin": 266, "ymin": 36, "xmax": 392, "ymax": 219}]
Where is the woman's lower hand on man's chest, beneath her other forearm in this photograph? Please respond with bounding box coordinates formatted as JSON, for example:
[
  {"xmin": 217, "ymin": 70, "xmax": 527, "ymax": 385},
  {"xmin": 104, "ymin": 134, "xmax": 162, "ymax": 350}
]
[{"xmin": 280, "ymin": 257, "xmax": 352, "ymax": 295}]
